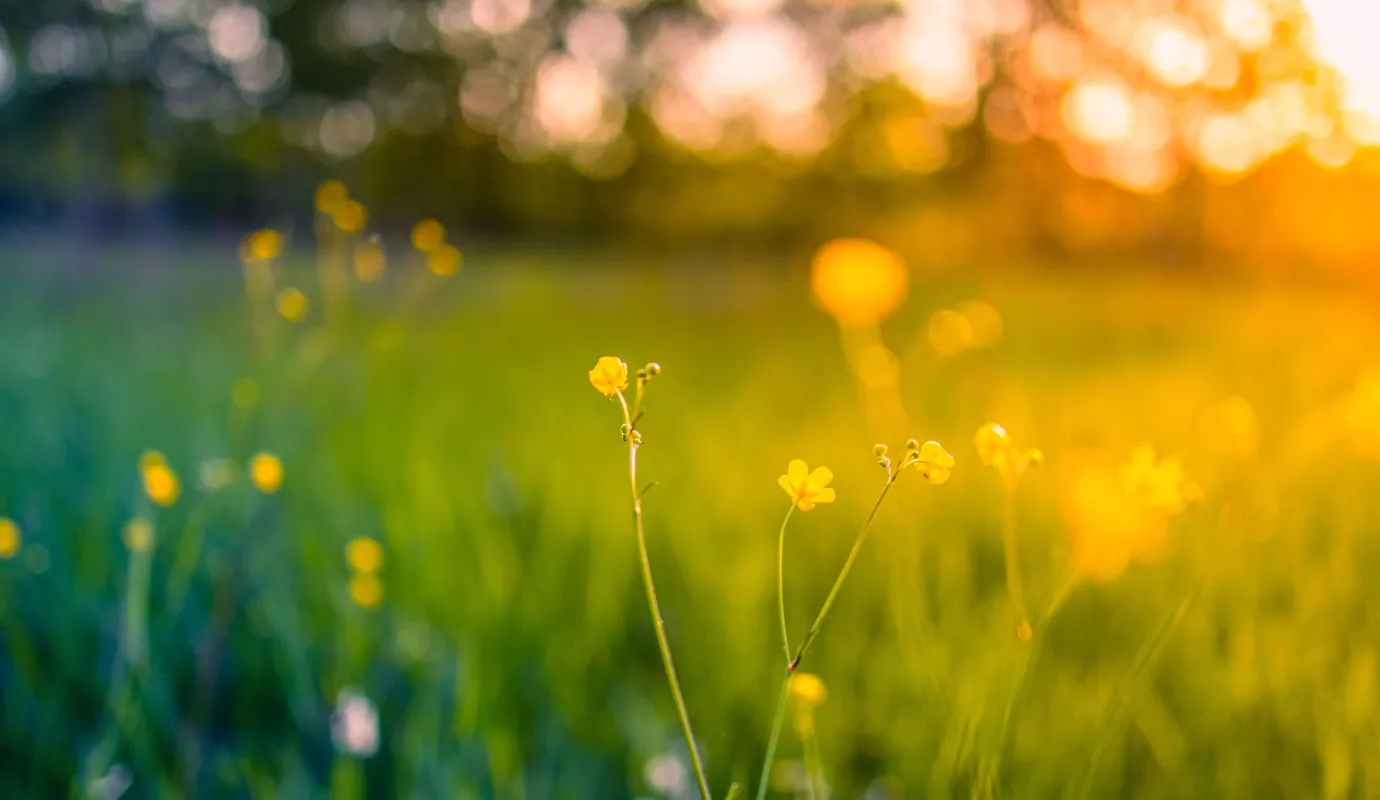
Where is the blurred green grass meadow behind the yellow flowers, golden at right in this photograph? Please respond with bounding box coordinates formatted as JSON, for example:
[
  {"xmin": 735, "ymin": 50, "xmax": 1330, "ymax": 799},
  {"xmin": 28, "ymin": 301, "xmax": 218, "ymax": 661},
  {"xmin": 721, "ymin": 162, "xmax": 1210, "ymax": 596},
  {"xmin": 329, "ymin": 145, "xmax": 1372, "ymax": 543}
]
[{"xmin": 0, "ymin": 251, "xmax": 1380, "ymax": 799}]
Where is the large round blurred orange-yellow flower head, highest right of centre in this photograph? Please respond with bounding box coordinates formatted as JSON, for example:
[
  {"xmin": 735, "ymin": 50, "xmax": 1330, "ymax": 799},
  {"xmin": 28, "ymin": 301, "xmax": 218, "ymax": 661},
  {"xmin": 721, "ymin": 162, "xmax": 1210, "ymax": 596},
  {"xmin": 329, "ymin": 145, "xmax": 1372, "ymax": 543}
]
[{"xmin": 810, "ymin": 239, "xmax": 909, "ymax": 326}]
